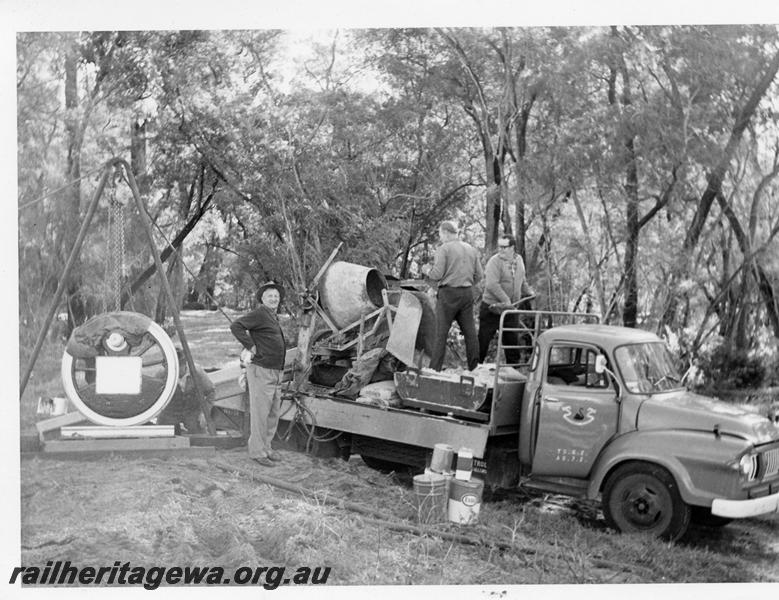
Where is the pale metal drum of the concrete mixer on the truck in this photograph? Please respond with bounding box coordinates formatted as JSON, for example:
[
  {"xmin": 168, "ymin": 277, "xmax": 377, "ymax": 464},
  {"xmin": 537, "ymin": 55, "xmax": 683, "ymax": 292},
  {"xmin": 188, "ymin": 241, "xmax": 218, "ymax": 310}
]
[{"xmin": 319, "ymin": 261, "xmax": 387, "ymax": 328}]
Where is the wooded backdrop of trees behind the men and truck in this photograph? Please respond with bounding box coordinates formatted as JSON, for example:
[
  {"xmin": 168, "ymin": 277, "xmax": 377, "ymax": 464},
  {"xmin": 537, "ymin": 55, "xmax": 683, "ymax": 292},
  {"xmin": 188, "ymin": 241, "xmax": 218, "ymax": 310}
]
[{"xmin": 17, "ymin": 26, "xmax": 779, "ymax": 386}]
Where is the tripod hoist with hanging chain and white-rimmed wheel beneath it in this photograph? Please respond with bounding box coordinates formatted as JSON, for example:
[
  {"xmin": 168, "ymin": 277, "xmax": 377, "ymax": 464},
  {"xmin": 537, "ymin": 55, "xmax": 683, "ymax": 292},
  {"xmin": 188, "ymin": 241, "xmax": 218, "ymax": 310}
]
[{"xmin": 19, "ymin": 158, "xmax": 216, "ymax": 435}]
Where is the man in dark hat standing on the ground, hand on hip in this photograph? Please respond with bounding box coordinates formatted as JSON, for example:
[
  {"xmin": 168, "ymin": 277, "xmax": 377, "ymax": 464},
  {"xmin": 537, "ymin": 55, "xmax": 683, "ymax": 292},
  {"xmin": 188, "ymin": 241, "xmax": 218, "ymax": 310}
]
[{"xmin": 230, "ymin": 281, "xmax": 287, "ymax": 467}]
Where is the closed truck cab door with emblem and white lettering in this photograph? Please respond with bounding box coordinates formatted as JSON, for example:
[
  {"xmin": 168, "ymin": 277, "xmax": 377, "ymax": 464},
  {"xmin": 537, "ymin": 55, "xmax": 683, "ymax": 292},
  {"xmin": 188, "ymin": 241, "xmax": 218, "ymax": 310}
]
[{"xmin": 532, "ymin": 343, "xmax": 619, "ymax": 478}]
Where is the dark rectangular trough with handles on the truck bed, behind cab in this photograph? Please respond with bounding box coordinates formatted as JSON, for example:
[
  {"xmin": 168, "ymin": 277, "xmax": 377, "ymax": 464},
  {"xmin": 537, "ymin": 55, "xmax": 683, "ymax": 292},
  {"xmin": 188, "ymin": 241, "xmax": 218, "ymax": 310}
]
[{"xmin": 395, "ymin": 369, "xmax": 489, "ymax": 421}]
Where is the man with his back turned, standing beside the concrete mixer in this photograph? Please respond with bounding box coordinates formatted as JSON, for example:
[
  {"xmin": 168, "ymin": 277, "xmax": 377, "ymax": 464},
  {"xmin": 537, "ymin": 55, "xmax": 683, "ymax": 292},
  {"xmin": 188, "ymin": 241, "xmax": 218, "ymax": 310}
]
[{"xmin": 422, "ymin": 221, "xmax": 483, "ymax": 371}]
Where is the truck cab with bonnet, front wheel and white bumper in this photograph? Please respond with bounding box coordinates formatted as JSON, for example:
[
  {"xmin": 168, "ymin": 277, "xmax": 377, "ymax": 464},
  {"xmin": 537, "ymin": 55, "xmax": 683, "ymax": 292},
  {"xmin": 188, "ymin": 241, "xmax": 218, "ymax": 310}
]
[{"xmin": 518, "ymin": 324, "xmax": 779, "ymax": 539}]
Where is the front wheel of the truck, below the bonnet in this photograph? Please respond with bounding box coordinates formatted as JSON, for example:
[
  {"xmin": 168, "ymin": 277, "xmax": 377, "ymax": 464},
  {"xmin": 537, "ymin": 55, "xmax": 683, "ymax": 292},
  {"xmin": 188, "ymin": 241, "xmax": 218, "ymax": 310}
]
[{"xmin": 603, "ymin": 462, "xmax": 691, "ymax": 541}]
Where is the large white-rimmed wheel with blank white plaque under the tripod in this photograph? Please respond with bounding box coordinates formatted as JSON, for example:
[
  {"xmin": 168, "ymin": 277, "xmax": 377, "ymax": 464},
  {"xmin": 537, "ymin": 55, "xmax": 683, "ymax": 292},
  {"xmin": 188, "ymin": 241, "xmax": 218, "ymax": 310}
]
[{"xmin": 61, "ymin": 311, "xmax": 178, "ymax": 427}]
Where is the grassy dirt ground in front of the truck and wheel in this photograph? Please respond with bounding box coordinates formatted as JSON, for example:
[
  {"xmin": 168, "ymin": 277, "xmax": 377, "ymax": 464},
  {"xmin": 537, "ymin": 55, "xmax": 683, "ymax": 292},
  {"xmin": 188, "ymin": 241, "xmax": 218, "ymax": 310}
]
[{"xmin": 20, "ymin": 314, "xmax": 779, "ymax": 585}]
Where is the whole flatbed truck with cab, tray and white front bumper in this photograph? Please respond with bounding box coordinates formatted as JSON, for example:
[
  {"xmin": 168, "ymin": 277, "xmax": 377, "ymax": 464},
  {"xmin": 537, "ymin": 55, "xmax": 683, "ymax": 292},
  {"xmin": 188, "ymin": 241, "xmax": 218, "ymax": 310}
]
[{"xmin": 213, "ymin": 264, "xmax": 779, "ymax": 540}]
